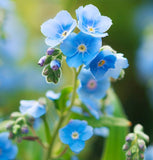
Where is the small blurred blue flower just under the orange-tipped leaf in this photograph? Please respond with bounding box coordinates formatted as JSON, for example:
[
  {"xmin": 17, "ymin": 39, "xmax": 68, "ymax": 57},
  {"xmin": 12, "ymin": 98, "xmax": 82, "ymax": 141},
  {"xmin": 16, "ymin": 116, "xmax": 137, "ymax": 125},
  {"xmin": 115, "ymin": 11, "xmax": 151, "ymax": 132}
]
[{"xmin": 94, "ymin": 127, "xmax": 109, "ymax": 138}]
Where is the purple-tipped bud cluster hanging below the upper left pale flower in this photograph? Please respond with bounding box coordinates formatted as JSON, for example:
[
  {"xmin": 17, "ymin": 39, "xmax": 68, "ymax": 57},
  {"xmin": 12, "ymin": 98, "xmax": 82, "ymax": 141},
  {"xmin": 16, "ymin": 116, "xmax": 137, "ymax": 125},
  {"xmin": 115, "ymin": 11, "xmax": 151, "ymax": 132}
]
[{"xmin": 38, "ymin": 48, "xmax": 62, "ymax": 83}]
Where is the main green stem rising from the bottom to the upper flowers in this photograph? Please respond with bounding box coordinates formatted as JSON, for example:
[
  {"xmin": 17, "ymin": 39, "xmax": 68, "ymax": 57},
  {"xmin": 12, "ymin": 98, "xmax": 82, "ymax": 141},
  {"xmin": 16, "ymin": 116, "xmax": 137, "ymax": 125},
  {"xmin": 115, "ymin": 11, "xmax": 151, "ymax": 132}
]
[{"xmin": 46, "ymin": 66, "xmax": 82, "ymax": 160}]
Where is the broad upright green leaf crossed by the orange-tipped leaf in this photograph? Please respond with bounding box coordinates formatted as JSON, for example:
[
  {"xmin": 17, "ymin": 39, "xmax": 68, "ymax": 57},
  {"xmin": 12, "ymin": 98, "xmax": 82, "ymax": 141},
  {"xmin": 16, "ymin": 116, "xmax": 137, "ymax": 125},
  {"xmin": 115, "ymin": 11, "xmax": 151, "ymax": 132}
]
[{"xmin": 101, "ymin": 89, "xmax": 128, "ymax": 160}]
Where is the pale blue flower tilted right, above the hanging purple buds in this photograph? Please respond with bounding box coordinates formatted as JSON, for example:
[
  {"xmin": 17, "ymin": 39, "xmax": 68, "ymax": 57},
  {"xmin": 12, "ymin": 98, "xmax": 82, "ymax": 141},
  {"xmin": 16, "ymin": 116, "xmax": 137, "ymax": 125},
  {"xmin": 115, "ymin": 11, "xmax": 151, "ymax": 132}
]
[{"xmin": 41, "ymin": 11, "xmax": 77, "ymax": 47}]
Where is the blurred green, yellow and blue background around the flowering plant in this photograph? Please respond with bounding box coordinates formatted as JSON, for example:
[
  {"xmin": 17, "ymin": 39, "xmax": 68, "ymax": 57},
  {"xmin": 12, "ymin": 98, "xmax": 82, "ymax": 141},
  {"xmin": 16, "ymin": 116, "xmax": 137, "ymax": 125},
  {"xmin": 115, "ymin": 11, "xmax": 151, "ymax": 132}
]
[{"xmin": 0, "ymin": 0, "xmax": 153, "ymax": 160}]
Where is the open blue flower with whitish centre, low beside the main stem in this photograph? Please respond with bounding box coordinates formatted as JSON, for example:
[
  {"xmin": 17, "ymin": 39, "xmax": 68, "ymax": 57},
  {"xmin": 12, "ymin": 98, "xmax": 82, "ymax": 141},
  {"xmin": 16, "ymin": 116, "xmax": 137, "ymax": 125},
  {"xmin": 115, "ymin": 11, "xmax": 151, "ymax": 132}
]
[{"xmin": 59, "ymin": 120, "xmax": 93, "ymax": 153}]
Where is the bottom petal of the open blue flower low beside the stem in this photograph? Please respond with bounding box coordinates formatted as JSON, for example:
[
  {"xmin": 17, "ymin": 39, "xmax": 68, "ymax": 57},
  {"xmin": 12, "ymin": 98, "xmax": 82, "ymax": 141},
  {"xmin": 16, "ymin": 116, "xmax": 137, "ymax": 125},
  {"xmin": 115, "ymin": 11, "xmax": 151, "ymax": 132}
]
[{"xmin": 69, "ymin": 140, "xmax": 85, "ymax": 153}]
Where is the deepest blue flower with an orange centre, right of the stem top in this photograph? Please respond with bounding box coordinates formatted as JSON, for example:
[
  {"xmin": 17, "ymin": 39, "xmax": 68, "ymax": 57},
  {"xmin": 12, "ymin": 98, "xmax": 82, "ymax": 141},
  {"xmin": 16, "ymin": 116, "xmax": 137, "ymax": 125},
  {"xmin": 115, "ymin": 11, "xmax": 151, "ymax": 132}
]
[{"xmin": 89, "ymin": 50, "xmax": 117, "ymax": 80}]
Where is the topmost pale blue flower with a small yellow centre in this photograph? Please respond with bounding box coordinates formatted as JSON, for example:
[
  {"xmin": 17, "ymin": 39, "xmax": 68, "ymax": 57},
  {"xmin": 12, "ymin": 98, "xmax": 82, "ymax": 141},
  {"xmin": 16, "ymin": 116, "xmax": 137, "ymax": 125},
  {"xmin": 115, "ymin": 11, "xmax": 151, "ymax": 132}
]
[{"xmin": 76, "ymin": 4, "xmax": 112, "ymax": 37}]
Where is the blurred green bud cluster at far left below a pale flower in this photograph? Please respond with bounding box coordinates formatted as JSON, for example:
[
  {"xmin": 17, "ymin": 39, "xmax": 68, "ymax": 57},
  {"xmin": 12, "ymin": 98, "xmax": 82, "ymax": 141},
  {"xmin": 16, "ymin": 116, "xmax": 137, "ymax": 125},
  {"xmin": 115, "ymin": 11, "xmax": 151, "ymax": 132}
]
[{"xmin": 6, "ymin": 112, "xmax": 34, "ymax": 142}]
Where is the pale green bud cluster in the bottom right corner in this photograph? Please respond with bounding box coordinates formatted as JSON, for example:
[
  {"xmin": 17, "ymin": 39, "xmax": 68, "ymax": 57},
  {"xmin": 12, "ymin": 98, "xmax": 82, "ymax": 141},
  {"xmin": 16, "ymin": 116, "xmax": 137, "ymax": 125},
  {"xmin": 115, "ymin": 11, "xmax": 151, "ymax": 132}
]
[{"xmin": 123, "ymin": 124, "xmax": 149, "ymax": 160}]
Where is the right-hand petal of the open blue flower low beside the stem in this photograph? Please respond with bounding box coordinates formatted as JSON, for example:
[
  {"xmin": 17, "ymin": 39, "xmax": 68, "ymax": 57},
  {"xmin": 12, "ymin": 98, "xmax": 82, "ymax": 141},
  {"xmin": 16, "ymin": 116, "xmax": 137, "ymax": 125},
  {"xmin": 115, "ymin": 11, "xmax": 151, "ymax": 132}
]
[{"xmin": 80, "ymin": 126, "xmax": 93, "ymax": 141}]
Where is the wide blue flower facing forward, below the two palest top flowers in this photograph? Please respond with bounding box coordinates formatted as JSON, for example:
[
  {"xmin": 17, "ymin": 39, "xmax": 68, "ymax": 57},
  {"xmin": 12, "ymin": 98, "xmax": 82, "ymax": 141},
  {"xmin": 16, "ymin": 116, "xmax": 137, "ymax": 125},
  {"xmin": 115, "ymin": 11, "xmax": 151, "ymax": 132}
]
[{"xmin": 60, "ymin": 32, "xmax": 102, "ymax": 68}]
